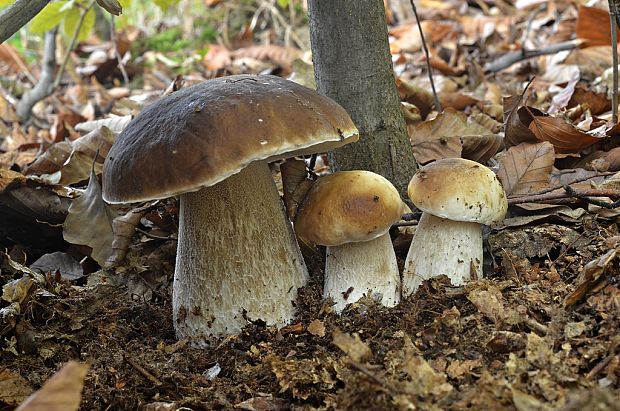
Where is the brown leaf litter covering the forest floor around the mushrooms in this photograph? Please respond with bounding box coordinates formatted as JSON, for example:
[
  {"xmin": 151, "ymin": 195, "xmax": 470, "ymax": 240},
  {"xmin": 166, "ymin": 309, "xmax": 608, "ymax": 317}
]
[{"xmin": 0, "ymin": 1, "xmax": 620, "ymax": 411}]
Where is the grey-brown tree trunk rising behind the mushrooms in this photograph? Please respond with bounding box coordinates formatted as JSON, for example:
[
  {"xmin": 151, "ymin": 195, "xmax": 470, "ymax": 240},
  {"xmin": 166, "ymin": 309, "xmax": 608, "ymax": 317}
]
[{"xmin": 308, "ymin": 0, "xmax": 417, "ymax": 198}]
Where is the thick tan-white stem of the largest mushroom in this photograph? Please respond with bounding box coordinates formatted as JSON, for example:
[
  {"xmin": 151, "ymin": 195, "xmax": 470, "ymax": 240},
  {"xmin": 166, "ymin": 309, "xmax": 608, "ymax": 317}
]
[{"xmin": 172, "ymin": 161, "xmax": 308, "ymax": 346}]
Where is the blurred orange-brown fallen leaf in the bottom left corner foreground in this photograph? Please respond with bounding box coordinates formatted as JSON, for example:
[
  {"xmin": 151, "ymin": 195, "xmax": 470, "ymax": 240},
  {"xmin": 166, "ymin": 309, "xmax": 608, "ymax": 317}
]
[{"xmin": 15, "ymin": 361, "xmax": 89, "ymax": 411}]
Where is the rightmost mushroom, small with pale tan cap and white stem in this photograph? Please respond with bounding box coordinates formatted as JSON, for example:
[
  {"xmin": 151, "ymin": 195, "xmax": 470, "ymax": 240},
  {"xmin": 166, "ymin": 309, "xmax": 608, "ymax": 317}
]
[{"xmin": 403, "ymin": 158, "xmax": 508, "ymax": 296}]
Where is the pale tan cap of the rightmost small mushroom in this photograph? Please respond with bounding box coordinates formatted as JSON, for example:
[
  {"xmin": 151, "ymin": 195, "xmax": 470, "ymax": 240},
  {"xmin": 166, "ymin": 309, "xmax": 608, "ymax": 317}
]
[{"xmin": 408, "ymin": 158, "xmax": 508, "ymax": 224}]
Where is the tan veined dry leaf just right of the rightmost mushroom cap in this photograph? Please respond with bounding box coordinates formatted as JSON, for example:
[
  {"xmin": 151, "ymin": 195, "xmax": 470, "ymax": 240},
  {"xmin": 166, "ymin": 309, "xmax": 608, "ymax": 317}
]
[{"xmin": 497, "ymin": 142, "xmax": 555, "ymax": 196}]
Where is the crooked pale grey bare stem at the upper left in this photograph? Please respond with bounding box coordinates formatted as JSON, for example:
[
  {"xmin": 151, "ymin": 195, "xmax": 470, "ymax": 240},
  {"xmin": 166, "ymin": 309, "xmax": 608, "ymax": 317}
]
[{"xmin": 16, "ymin": 28, "xmax": 58, "ymax": 122}]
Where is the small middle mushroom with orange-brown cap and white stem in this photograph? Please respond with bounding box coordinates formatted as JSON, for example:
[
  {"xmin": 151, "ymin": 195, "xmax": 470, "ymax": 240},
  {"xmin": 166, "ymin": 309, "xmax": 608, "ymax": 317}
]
[{"xmin": 295, "ymin": 171, "xmax": 405, "ymax": 313}]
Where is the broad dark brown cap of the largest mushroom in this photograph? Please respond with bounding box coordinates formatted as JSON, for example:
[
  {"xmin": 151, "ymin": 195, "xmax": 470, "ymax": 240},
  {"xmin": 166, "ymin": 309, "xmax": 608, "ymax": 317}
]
[{"xmin": 103, "ymin": 75, "xmax": 358, "ymax": 203}]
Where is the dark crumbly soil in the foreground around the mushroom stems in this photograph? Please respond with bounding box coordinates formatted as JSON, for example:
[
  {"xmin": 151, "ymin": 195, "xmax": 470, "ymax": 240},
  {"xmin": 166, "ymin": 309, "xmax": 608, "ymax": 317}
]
[{"xmin": 0, "ymin": 212, "xmax": 620, "ymax": 410}]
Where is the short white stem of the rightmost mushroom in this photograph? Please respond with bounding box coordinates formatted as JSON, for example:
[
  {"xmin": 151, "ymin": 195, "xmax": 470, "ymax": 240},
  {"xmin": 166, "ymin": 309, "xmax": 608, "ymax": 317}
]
[{"xmin": 403, "ymin": 213, "xmax": 482, "ymax": 297}]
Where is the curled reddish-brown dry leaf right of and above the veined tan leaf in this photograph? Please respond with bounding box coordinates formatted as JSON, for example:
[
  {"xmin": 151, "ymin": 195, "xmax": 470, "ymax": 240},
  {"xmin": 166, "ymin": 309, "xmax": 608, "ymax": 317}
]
[{"xmin": 529, "ymin": 116, "xmax": 601, "ymax": 153}]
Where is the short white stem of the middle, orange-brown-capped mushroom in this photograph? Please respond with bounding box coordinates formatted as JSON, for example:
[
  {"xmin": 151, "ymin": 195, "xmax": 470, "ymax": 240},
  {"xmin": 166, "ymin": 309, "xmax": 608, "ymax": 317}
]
[{"xmin": 323, "ymin": 233, "xmax": 400, "ymax": 313}]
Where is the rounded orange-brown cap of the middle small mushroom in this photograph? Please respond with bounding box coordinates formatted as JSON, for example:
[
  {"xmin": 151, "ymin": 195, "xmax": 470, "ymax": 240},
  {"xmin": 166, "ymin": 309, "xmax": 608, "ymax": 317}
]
[{"xmin": 295, "ymin": 170, "xmax": 405, "ymax": 246}]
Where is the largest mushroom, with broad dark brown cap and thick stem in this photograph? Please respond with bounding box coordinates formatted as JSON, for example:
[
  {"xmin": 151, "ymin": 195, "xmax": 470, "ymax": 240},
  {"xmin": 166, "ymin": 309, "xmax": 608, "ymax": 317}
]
[{"xmin": 103, "ymin": 75, "xmax": 357, "ymax": 346}]
